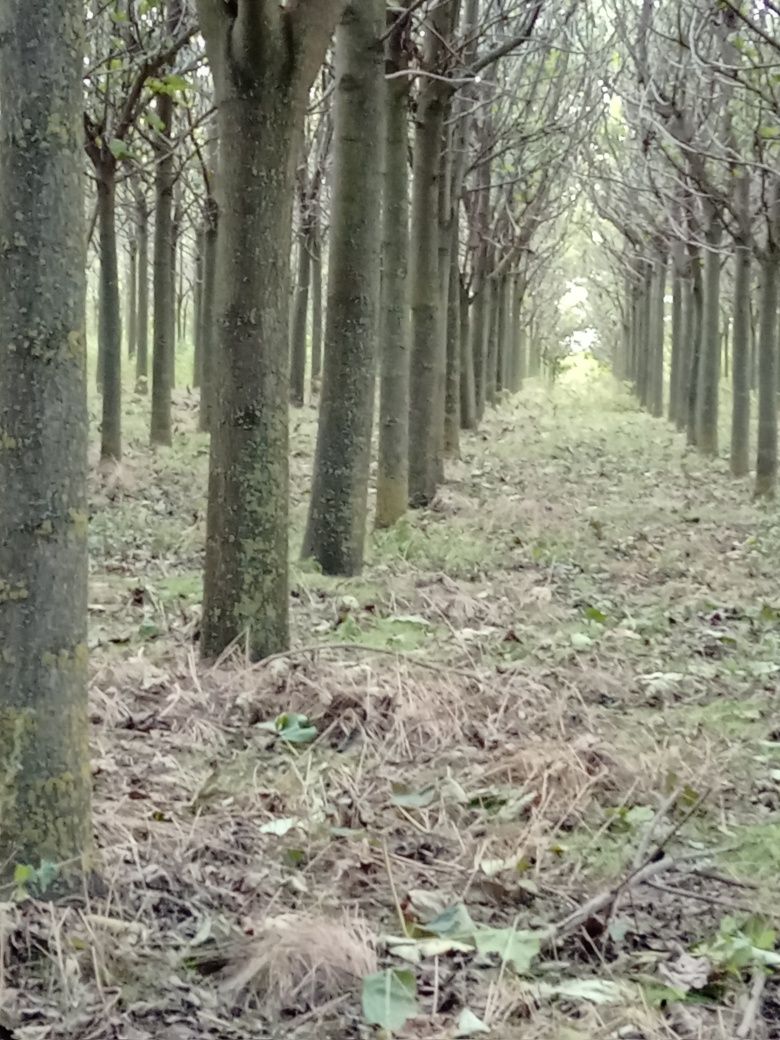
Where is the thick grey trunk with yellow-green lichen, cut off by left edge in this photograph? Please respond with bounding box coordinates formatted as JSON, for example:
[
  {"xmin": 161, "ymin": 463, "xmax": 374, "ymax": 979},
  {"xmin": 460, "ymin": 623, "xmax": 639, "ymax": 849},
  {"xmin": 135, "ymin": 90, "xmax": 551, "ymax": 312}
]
[{"xmin": 0, "ymin": 0, "xmax": 92, "ymax": 887}]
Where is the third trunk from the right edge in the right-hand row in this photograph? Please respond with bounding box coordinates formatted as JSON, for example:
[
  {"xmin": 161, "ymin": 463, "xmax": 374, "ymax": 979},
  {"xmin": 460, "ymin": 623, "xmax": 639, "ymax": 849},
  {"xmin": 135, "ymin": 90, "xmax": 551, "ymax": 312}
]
[{"xmin": 697, "ymin": 217, "xmax": 723, "ymax": 456}]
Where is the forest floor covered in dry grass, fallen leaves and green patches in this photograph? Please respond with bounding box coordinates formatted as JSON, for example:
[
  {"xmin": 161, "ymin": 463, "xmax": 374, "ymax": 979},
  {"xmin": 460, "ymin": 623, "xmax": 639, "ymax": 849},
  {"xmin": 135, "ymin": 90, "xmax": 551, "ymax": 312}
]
[{"xmin": 0, "ymin": 363, "xmax": 780, "ymax": 1040}]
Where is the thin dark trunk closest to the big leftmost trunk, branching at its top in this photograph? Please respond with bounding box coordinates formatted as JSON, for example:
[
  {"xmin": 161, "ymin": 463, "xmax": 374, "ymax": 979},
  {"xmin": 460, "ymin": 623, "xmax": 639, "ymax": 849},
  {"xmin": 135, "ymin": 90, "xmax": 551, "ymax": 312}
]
[{"xmin": 98, "ymin": 169, "xmax": 122, "ymax": 462}]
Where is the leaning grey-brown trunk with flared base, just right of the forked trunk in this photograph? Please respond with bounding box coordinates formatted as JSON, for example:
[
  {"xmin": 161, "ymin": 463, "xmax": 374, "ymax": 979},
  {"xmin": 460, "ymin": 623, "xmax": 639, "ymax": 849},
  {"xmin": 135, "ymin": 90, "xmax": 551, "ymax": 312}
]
[{"xmin": 304, "ymin": 0, "xmax": 386, "ymax": 575}]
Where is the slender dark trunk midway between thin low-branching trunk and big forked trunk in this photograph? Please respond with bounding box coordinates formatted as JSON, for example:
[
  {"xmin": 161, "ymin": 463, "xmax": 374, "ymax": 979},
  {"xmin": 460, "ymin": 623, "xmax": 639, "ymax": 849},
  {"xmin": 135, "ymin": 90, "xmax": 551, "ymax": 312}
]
[{"xmin": 151, "ymin": 94, "xmax": 176, "ymax": 444}]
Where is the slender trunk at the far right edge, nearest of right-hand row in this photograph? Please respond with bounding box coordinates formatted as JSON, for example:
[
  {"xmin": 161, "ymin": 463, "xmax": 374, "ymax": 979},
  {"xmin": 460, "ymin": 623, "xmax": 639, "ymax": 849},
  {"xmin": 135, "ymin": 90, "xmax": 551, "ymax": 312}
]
[{"xmin": 756, "ymin": 243, "xmax": 780, "ymax": 498}]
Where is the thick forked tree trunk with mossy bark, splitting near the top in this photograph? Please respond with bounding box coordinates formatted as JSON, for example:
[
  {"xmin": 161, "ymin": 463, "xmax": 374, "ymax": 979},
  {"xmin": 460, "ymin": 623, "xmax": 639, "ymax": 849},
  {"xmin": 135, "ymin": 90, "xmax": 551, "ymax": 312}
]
[{"xmin": 198, "ymin": 0, "xmax": 344, "ymax": 657}]
